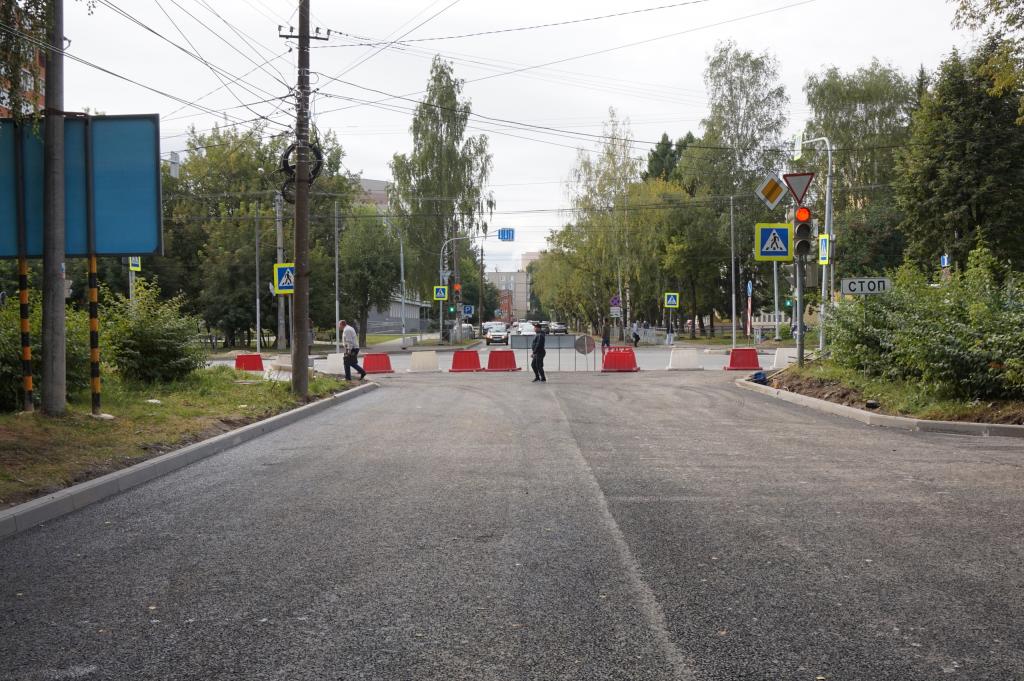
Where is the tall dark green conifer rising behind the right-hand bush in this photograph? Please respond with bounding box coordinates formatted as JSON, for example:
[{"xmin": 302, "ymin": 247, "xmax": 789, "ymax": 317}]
[{"xmin": 895, "ymin": 40, "xmax": 1024, "ymax": 267}]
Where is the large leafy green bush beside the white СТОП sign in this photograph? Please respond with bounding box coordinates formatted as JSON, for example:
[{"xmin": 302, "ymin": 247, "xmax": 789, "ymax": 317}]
[{"xmin": 827, "ymin": 248, "xmax": 1024, "ymax": 398}]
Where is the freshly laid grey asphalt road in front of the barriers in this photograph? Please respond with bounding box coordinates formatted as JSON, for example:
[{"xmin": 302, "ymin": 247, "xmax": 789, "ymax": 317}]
[{"xmin": 0, "ymin": 372, "xmax": 1024, "ymax": 681}]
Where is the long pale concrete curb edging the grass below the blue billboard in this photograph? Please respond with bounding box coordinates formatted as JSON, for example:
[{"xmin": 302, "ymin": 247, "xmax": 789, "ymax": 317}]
[{"xmin": 0, "ymin": 383, "xmax": 380, "ymax": 539}]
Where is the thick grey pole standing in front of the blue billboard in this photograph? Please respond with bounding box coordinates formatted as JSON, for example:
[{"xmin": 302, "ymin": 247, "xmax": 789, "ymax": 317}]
[{"xmin": 42, "ymin": 0, "xmax": 66, "ymax": 416}]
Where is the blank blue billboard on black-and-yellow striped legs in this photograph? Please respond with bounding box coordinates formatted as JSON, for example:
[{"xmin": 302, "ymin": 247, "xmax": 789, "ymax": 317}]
[{"xmin": 0, "ymin": 115, "xmax": 163, "ymax": 258}]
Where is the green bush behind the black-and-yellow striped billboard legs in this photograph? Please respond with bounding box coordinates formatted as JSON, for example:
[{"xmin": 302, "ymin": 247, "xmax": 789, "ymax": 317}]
[{"xmin": 0, "ymin": 294, "xmax": 89, "ymax": 412}]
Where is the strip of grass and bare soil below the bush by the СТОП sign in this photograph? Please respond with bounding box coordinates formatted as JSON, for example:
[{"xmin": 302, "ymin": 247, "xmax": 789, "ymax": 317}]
[{"xmin": 772, "ymin": 360, "xmax": 1024, "ymax": 424}]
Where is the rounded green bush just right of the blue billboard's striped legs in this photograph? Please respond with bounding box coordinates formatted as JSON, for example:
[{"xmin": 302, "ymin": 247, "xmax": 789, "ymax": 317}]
[{"xmin": 100, "ymin": 279, "xmax": 206, "ymax": 383}]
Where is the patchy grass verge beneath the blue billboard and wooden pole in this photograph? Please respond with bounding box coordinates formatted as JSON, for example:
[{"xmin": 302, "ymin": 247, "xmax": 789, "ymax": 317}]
[{"xmin": 0, "ymin": 367, "xmax": 348, "ymax": 508}]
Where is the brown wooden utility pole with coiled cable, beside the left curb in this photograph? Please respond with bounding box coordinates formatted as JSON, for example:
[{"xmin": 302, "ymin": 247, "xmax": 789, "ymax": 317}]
[{"xmin": 292, "ymin": 0, "xmax": 309, "ymax": 399}]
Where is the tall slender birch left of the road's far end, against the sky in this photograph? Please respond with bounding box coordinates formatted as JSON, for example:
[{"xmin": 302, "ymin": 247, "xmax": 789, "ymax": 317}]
[{"xmin": 389, "ymin": 56, "xmax": 494, "ymax": 295}]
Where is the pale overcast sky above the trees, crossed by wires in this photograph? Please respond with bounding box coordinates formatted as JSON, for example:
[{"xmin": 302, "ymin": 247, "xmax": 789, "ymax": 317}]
[{"xmin": 65, "ymin": 0, "xmax": 975, "ymax": 270}]
